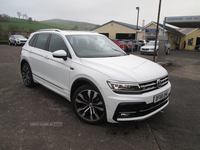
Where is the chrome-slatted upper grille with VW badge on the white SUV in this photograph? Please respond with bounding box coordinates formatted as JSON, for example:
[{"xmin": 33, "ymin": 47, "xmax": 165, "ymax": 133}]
[{"xmin": 139, "ymin": 76, "xmax": 169, "ymax": 93}]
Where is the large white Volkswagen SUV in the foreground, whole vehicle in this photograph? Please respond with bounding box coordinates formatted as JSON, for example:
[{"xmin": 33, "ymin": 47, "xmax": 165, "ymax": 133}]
[{"xmin": 20, "ymin": 29, "xmax": 171, "ymax": 124}]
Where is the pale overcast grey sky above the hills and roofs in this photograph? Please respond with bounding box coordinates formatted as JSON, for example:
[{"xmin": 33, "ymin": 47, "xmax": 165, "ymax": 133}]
[{"xmin": 0, "ymin": 0, "xmax": 200, "ymax": 26}]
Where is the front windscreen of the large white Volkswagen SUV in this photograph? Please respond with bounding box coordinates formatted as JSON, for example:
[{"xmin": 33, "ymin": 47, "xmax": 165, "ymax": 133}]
[{"xmin": 66, "ymin": 35, "xmax": 126, "ymax": 57}]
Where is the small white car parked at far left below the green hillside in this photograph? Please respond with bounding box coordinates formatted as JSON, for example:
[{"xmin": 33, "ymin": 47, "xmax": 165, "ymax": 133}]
[{"xmin": 8, "ymin": 35, "xmax": 27, "ymax": 46}]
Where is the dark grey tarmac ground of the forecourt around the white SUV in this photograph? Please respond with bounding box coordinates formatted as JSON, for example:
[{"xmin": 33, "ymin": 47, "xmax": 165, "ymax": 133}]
[{"xmin": 0, "ymin": 45, "xmax": 200, "ymax": 150}]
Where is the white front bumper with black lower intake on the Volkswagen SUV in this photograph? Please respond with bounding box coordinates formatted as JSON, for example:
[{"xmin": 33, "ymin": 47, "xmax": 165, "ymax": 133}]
[{"xmin": 106, "ymin": 82, "xmax": 171, "ymax": 123}]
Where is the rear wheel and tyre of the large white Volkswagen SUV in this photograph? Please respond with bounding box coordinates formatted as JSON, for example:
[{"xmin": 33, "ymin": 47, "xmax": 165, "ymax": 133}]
[{"xmin": 21, "ymin": 63, "xmax": 35, "ymax": 87}]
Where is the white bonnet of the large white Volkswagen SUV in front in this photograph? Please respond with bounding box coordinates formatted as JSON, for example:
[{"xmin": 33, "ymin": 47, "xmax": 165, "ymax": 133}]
[{"xmin": 81, "ymin": 55, "xmax": 168, "ymax": 82}]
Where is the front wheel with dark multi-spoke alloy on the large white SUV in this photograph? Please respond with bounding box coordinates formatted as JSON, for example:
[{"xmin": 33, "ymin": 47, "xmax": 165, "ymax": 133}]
[{"xmin": 72, "ymin": 85, "xmax": 106, "ymax": 124}]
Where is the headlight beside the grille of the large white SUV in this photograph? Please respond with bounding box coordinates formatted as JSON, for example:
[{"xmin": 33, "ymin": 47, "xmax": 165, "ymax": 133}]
[{"xmin": 107, "ymin": 81, "xmax": 142, "ymax": 94}]
